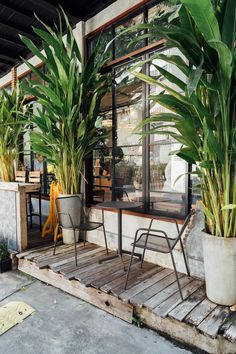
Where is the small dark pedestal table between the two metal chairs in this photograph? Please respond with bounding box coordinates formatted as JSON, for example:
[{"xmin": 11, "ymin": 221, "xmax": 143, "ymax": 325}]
[{"xmin": 98, "ymin": 201, "xmax": 143, "ymax": 263}]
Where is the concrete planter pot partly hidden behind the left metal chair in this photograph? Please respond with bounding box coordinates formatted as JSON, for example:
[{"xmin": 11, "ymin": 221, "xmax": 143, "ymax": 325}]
[{"xmin": 60, "ymin": 194, "xmax": 83, "ymax": 244}]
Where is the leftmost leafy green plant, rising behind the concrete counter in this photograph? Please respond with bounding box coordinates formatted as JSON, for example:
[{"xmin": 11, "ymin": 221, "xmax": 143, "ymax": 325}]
[{"xmin": 0, "ymin": 87, "xmax": 29, "ymax": 182}]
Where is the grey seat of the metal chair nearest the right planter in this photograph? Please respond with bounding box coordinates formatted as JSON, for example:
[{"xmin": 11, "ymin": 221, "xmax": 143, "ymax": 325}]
[{"xmin": 131, "ymin": 230, "xmax": 176, "ymax": 253}]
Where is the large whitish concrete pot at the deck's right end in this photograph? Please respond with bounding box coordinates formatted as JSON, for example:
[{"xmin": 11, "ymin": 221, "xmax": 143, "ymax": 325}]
[{"xmin": 202, "ymin": 232, "xmax": 236, "ymax": 306}]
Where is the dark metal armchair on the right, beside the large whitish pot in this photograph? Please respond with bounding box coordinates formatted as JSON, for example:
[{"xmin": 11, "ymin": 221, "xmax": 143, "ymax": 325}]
[{"xmin": 125, "ymin": 210, "xmax": 195, "ymax": 300}]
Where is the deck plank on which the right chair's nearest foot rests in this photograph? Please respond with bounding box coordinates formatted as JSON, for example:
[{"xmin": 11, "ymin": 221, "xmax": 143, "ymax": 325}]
[{"xmin": 153, "ymin": 280, "xmax": 203, "ymax": 317}]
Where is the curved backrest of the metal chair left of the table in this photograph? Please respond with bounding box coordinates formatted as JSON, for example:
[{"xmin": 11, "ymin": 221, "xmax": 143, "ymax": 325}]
[{"xmin": 55, "ymin": 195, "xmax": 83, "ymax": 228}]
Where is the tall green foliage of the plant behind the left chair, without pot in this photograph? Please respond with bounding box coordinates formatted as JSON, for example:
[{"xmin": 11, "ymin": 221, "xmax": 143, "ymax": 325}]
[{"xmin": 21, "ymin": 9, "xmax": 108, "ymax": 194}]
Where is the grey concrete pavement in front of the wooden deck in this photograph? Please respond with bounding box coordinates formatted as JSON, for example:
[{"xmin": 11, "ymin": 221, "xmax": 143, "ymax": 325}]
[{"xmin": 0, "ymin": 272, "xmax": 202, "ymax": 354}]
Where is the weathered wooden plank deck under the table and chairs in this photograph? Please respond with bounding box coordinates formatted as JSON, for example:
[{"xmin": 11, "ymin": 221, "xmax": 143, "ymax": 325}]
[{"xmin": 18, "ymin": 243, "xmax": 236, "ymax": 353}]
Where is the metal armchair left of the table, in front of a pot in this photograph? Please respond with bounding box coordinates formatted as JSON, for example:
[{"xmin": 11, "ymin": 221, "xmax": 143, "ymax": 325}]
[{"xmin": 53, "ymin": 195, "xmax": 108, "ymax": 266}]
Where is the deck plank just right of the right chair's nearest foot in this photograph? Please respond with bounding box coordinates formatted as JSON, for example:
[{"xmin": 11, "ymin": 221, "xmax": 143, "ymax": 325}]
[{"xmin": 168, "ymin": 285, "xmax": 206, "ymax": 321}]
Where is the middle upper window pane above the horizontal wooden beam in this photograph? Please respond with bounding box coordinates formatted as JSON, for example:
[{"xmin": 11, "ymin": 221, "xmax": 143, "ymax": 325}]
[{"xmin": 115, "ymin": 13, "xmax": 145, "ymax": 58}]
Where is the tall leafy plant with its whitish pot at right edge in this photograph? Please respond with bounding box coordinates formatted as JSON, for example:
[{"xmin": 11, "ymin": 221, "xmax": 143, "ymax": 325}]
[{"xmin": 130, "ymin": 0, "xmax": 236, "ymax": 305}]
